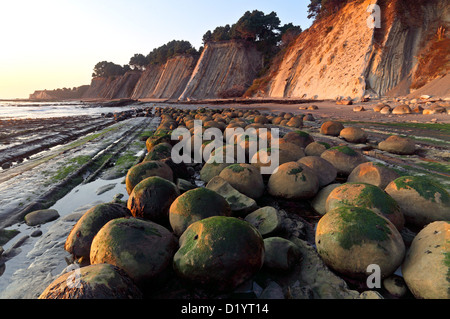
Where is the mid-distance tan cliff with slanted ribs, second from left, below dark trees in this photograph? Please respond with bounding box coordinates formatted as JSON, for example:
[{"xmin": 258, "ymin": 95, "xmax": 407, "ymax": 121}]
[{"xmin": 131, "ymin": 55, "xmax": 197, "ymax": 99}]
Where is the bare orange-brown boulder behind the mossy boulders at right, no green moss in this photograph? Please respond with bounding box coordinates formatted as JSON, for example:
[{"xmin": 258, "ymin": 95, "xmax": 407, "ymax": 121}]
[{"xmin": 347, "ymin": 162, "xmax": 400, "ymax": 189}]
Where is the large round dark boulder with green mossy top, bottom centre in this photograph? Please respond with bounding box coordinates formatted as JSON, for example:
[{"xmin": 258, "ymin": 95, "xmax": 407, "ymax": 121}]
[{"xmin": 173, "ymin": 216, "xmax": 264, "ymax": 292}]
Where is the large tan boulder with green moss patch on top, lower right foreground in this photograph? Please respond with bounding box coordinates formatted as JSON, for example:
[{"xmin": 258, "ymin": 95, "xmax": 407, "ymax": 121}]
[{"xmin": 315, "ymin": 206, "xmax": 405, "ymax": 280}]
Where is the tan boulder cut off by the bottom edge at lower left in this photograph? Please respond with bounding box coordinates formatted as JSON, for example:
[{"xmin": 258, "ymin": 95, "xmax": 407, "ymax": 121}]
[{"xmin": 39, "ymin": 264, "xmax": 143, "ymax": 299}]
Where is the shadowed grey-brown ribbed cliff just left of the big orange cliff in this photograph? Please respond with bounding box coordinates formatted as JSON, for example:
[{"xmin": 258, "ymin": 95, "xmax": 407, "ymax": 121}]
[{"xmin": 179, "ymin": 41, "xmax": 263, "ymax": 101}]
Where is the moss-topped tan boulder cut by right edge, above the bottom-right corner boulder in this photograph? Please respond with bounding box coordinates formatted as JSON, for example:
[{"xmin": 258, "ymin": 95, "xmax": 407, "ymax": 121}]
[{"xmin": 385, "ymin": 176, "xmax": 450, "ymax": 228}]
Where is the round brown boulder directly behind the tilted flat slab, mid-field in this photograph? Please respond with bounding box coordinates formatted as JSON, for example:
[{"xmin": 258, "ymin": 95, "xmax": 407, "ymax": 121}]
[{"xmin": 219, "ymin": 163, "xmax": 264, "ymax": 199}]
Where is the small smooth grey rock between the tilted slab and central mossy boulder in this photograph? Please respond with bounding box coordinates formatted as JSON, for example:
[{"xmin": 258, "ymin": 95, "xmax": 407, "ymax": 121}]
[{"xmin": 245, "ymin": 206, "xmax": 282, "ymax": 237}]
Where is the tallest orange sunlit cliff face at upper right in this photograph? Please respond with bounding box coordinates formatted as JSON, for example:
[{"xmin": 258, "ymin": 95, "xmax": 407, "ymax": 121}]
[{"xmin": 259, "ymin": 0, "xmax": 450, "ymax": 99}]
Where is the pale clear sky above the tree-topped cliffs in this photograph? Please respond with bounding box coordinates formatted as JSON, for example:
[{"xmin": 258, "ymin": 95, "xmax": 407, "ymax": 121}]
[{"xmin": 0, "ymin": 0, "xmax": 311, "ymax": 99}]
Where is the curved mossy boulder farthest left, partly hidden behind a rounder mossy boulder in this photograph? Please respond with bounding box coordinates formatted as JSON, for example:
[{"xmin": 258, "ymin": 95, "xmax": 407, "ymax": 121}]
[{"xmin": 64, "ymin": 203, "xmax": 131, "ymax": 259}]
